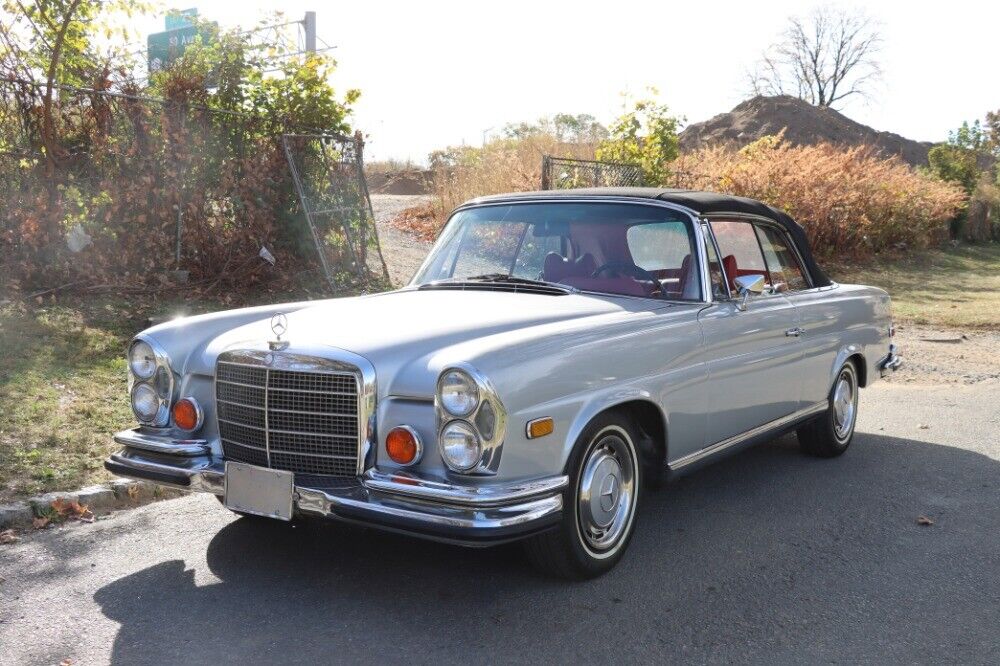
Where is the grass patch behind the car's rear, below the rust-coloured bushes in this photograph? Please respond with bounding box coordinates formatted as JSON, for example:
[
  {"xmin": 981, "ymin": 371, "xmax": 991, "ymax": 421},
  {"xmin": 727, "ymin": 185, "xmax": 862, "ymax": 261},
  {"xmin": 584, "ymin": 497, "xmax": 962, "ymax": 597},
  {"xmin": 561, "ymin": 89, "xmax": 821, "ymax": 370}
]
[{"xmin": 827, "ymin": 243, "xmax": 1000, "ymax": 330}]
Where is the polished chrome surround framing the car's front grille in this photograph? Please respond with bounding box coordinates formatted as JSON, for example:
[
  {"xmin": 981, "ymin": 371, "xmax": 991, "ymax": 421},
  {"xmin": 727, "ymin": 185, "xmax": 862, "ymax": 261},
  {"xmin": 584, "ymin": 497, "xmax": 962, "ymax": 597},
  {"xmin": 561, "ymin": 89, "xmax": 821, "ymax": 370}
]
[{"xmin": 212, "ymin": 348, "xmax": 378, "ymax": 476}]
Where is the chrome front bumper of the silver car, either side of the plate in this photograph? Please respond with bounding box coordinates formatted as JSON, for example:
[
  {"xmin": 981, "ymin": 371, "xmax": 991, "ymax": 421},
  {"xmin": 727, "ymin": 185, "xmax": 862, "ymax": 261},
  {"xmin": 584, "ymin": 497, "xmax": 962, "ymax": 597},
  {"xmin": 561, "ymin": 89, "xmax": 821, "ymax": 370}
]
[{"xmin": 104, "ymin": 431, "xmax": 568, "ymax": 546}]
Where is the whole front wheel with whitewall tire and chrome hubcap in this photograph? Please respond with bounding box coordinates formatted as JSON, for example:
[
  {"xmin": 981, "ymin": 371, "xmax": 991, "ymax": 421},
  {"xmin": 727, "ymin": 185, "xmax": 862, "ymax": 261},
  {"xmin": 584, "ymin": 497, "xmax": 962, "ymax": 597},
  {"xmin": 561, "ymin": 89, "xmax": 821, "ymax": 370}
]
[{"xmin": 525, "ymin": 412, "xmax": 642, "ymax": 580}]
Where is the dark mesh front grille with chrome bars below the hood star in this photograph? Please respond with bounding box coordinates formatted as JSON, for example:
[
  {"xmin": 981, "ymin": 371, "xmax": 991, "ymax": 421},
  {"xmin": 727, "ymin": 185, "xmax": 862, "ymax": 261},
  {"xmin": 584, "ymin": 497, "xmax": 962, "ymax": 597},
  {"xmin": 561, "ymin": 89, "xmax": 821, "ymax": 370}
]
[{"xmin": 215, "ymin": 352, "xmax": 359, "ymax": 476}]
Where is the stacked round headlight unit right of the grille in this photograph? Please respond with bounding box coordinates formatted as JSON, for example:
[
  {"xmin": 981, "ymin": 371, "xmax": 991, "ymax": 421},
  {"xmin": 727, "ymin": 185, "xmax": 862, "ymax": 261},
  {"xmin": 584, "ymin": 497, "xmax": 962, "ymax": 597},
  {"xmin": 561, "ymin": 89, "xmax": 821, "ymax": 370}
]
[{"xmin": 436, "ymin": 367, "xmax": 506, "ymax": 474}]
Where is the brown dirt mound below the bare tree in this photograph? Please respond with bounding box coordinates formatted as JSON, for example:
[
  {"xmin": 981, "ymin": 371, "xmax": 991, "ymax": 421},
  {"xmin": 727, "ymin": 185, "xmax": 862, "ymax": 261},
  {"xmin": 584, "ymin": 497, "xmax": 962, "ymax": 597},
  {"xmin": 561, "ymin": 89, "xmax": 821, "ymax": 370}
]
[{"xmin": 680, "ymin": 95, "xmax": 934, "ymax": 166}]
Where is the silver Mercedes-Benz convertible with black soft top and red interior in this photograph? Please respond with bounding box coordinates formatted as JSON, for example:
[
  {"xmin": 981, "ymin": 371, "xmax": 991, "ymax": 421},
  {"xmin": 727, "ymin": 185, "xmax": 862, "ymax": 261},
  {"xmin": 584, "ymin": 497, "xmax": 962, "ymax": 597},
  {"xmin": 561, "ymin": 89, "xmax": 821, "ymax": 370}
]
[{"xmin": 105, "ymin": 188, "xmax": 901, "ymax": 578}]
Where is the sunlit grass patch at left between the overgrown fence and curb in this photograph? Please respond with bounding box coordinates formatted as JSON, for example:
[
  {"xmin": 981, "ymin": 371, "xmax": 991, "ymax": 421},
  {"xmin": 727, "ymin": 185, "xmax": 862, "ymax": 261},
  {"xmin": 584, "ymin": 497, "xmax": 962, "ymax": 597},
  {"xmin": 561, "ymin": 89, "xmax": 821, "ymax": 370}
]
[{"xmin": 0, "ymin": 302, "xmax": 144, "ymax": 501}]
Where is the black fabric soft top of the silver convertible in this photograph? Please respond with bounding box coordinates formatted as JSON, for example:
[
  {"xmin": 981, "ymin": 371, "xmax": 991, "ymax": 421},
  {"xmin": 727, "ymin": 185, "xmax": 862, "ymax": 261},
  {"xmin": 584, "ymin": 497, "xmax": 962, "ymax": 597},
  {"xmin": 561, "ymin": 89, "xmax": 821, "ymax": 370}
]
[{"xmin": 464, "ymin": 187, "xmax": 831, "ymax": 287}]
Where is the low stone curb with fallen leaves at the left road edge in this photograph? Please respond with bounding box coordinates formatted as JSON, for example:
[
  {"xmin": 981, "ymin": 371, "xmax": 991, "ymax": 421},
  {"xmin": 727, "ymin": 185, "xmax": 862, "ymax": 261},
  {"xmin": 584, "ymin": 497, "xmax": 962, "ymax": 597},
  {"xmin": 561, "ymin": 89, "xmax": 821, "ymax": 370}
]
[{"xmin": 0, "ymin": 479, "xmax": 187, "ymax": 529}]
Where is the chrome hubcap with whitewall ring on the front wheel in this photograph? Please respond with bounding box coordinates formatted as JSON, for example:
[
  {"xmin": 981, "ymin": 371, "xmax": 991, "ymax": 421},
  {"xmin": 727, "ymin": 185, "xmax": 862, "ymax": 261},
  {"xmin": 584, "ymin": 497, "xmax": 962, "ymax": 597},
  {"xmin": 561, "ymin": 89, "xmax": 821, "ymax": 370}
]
[{"xmin": 578, "ymin": 434, "xmax": 635, "ymax": 551}]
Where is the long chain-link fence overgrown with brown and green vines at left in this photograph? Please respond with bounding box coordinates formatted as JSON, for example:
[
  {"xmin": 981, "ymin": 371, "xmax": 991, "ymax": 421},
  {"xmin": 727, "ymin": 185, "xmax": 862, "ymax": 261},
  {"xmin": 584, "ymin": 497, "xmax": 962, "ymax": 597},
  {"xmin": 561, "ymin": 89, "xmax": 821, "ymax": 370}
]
[{"xmin": 0, "ymin": 75, "xmax": 388, "ymax": 291}]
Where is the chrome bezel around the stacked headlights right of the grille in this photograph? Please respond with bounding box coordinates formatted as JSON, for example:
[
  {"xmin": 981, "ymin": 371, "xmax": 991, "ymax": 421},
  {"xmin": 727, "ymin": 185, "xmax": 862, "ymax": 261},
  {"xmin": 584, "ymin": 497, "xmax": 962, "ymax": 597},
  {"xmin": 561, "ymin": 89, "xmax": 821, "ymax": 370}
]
[{"xmin": 434, "ymin": 363, "xmax": 507, "ymax": 475}]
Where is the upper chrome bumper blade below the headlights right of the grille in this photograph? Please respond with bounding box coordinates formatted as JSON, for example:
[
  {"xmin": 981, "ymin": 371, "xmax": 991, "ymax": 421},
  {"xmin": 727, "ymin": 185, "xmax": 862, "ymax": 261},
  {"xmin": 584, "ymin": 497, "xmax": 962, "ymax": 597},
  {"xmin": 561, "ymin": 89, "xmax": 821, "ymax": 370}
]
[{"xmin": 362, "ymin": 469, "xmax": 569, "ymax": 506}]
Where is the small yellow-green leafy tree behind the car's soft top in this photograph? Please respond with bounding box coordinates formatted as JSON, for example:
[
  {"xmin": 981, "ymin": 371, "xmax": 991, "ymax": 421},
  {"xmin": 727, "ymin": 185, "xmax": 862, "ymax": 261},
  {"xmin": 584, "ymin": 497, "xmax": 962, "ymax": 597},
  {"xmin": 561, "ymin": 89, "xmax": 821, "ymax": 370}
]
[{"xmin": 595, "ymin": 88, "xmax": 683, "ymax": 185}]
